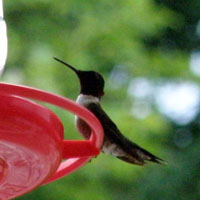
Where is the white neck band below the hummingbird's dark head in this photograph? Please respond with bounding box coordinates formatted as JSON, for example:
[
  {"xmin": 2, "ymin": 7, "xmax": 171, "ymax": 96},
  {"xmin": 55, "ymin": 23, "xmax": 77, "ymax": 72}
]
[{"xmin": 76, "ymin": 94, "xmax": 100, "ymax": 106}]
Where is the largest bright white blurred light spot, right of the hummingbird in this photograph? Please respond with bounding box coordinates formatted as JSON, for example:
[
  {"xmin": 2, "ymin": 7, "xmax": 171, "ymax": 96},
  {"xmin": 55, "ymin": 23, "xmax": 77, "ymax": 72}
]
[{"xmin": 155, "ymin": 82, "xmax": 200, "ymax": 125}]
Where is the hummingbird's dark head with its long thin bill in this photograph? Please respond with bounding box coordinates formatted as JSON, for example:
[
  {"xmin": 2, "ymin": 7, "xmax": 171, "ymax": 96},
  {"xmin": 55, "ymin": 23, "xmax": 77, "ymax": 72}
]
[{"xmin": 54, "ymin": 58, "xmax": 105, "ymax": 98}]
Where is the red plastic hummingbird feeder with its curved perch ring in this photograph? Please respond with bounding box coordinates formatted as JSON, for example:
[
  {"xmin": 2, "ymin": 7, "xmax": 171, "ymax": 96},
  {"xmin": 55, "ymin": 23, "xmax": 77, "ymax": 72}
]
[{"xmin": 0, "ymin": 83, "xmax": 103, "ymax": 200}]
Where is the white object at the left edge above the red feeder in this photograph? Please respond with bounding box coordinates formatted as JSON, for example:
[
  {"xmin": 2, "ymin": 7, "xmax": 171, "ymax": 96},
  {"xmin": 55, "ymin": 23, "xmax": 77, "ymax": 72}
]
[{"xmin": 0, "ymin": 0, "xmax": 7, "ymax": 76}]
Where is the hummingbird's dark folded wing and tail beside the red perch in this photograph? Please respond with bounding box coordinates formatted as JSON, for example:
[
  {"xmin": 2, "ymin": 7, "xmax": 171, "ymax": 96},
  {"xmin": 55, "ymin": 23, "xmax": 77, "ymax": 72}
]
[{"xmin": 87, "ymin": 103, "xmax": 163, "ymax": 165}]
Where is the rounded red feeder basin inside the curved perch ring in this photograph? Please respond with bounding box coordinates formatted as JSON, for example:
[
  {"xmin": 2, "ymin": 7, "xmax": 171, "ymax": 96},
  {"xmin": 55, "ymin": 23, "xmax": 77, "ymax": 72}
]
[{"xmin": 0, "ymin": 95, "xmax": 63, "ymax": 199}]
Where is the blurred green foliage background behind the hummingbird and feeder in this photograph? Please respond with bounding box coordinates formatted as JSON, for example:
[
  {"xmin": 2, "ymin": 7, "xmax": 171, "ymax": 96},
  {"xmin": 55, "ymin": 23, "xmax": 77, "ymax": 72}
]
[{"xmin": 2, "ymin": 0, "xmax": 200, "ymax": 200}]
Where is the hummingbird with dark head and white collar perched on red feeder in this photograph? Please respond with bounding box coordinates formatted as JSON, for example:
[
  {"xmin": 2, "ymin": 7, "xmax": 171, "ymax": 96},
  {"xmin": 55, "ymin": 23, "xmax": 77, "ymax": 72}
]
[{"xmin": 54, "ymin": 57, "xmax": 163, "ymax": 165}]
